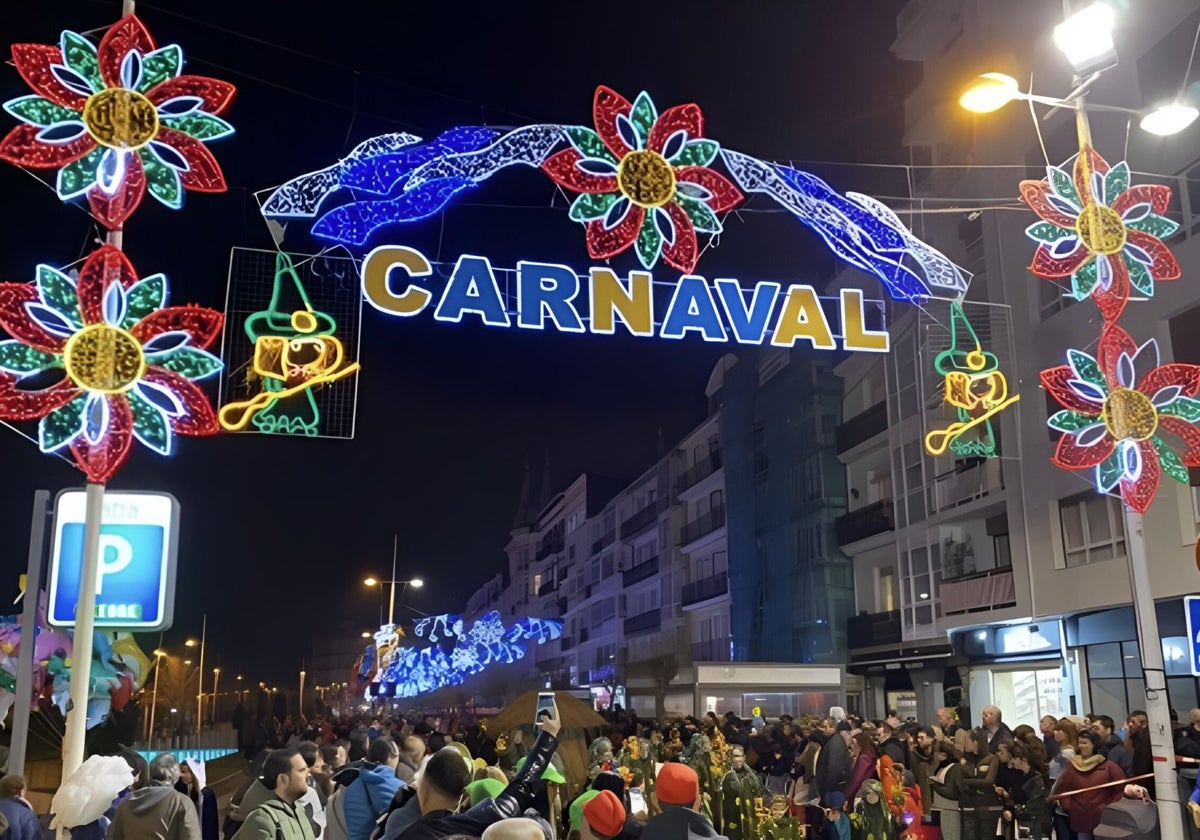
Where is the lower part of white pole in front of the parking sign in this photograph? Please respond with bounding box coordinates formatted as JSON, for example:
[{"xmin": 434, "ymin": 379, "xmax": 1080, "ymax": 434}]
[{"xmin": 62, "ymin": 481, "xmax": 104, "ymax": 782}]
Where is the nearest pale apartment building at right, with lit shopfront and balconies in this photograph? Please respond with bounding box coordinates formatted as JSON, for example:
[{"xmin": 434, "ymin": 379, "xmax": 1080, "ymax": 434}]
[{"xmin": 836, "ymin": 0, "xmax": 1200, "ymax": 725}]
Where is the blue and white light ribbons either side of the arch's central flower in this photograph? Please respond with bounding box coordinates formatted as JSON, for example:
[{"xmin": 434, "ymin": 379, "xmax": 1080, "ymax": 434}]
[{"xmin": 263, "ymin": 124, "xmax": 967, "ymax": 301}]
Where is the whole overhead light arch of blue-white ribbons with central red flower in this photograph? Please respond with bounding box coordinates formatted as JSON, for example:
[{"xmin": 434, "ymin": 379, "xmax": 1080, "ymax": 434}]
[{"xmin": 263, "ymin": 86, "xmax": 966, "ymax": 300}]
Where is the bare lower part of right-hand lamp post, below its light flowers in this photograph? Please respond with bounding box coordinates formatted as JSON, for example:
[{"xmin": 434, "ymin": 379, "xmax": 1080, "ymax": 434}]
[{"xmin": 1126, "ymin": 508, "xmax": 1183, "ymax": 840}]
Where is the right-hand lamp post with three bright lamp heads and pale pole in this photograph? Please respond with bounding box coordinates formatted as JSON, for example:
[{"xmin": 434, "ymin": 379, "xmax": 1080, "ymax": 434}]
[{"xmin": 959, "ymin": 2, "xmax": 1180, "ymax": 840}]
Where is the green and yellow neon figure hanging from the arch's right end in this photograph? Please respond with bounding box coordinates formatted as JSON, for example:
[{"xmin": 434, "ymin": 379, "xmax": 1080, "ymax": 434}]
[{"xmin": 925, "ymin": 302, "xmax": 1021, "ymax": 458}]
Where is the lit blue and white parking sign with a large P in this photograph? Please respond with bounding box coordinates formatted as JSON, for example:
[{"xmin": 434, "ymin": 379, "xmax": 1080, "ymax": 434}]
[{"xmin": 47, "ymin": 490, "xmax": 179, "ymax": 631}]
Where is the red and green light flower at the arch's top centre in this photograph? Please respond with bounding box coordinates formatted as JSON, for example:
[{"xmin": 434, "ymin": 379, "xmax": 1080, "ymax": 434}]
[{"xmin": 541, "ymin": 85, "xmax": 744, "ymax": 274}]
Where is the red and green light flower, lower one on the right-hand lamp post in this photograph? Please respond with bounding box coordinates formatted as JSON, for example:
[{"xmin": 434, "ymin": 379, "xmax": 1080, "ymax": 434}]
[{"xmin": 1042, "ymin": 324, "xmax": 1200, "ymax": 514}]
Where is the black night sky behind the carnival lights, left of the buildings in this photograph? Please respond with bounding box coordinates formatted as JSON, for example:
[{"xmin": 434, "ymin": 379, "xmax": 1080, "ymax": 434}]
[{"xmin": 0, "ymin": 0, "xmax": 919, "ymax": 680}]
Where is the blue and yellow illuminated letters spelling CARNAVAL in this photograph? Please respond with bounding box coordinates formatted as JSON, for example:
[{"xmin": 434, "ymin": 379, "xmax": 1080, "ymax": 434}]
[{"xmin": 361, "ymin": 245, "xmax": 889, "ymax": 353}]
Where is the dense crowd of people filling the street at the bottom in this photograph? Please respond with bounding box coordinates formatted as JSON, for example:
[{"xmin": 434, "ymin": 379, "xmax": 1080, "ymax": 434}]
[{"xmin": 30, "ymin": 706, "xmax": 1200, "ymax": 840}]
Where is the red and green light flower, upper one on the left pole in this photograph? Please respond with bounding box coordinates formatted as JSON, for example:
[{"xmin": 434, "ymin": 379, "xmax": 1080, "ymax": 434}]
[{"xmin": 0, "ymin": 14, "xmax": 235, "ymax": 229}]
